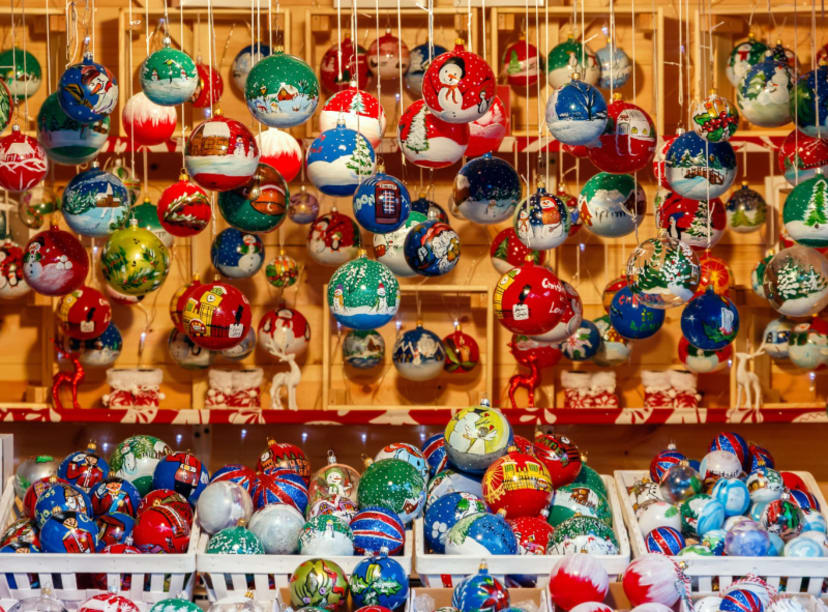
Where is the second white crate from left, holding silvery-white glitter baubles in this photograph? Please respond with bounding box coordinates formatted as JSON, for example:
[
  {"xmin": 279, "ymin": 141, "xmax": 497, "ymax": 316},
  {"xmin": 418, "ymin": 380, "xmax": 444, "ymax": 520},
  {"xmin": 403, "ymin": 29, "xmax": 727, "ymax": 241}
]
[{"xmin": 196, "ymin": 530, "xmax": 414, "ymax": 602}]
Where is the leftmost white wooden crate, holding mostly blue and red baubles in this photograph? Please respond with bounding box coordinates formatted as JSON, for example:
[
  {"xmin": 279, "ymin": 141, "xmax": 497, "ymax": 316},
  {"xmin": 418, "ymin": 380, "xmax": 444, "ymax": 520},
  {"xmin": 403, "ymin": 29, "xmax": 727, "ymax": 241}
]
[{"xmin": 0, "ymin": 478, "xmax": 201, "ymax": 610}]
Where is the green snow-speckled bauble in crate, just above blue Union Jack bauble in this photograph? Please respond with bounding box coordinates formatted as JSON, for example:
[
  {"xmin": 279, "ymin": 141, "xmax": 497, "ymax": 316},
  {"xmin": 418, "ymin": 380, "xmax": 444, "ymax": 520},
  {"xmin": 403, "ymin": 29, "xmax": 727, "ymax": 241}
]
[{"xmin": 357, "ymin": 459, "xmax": 425, "ymax": 524}]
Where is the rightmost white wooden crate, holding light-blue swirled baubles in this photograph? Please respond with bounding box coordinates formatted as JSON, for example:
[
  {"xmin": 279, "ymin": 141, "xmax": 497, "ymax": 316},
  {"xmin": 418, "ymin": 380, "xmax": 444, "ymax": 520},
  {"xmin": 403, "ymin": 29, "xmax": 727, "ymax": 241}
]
[{"xmin": 615, "ymin": 470, "xmax": 828, "ymax": 596}]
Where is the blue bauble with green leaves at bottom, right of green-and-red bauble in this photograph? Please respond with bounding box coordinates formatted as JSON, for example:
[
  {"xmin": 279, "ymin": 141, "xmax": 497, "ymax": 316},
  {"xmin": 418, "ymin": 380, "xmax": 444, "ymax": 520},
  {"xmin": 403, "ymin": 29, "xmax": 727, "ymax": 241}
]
[{"xmin": 348, "ymin": 554, "xmax": 408, "ymax": 610}]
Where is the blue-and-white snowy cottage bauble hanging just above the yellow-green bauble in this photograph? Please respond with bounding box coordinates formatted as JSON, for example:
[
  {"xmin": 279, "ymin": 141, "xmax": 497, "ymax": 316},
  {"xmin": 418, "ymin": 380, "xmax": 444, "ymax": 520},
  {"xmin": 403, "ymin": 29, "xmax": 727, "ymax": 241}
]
[{"xmin": 61, "ymin": 162, "xmax": 129, "ymax": 240}]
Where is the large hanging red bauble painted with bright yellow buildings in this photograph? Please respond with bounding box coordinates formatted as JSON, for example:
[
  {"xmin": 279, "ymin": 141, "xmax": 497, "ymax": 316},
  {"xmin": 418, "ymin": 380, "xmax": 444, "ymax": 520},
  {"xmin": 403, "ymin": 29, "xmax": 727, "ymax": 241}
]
[{"xmin": 181, "ymin": 282, "xmax": 252, "ymax": 351}]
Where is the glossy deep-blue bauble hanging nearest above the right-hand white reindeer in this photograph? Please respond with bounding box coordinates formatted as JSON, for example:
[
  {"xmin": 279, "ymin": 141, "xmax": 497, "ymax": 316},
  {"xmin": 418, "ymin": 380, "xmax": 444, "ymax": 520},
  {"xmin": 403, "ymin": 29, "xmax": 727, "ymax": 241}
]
[{"xmin": 681, "ymin": 286, "xmax": 739, "ymax": 350}]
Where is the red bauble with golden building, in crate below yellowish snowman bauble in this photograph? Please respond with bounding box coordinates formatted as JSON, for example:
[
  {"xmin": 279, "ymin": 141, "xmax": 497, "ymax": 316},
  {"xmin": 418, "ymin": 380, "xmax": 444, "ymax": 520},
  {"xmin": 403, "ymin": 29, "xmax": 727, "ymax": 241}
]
[{"xmin": 483, "ymin": 450, "xmax": 555, "ymax": 518}]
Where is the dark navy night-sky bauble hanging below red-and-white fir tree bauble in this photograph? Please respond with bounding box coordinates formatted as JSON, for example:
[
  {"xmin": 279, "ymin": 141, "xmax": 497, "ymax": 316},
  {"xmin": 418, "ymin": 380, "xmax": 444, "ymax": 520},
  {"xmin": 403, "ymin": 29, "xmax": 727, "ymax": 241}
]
[{"xmin": 451, "ymin": 153, "xmax": 522, "ymax": 225}]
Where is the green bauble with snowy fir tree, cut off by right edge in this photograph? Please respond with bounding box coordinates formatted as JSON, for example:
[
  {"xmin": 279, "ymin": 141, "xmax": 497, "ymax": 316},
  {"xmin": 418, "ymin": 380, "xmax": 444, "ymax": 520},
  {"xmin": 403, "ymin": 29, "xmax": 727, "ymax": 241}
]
[{"xmin": 782, "ymin": 174, "xmax": 828, "ymax": 248}]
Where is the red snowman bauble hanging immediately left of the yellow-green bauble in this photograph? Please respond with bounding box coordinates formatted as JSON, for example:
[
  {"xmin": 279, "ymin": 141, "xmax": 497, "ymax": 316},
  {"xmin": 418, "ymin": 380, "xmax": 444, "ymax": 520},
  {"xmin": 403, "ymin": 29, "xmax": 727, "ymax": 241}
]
[{"xmin": 23, "ymin": 225, "xmax": 89, "ymax": 295}]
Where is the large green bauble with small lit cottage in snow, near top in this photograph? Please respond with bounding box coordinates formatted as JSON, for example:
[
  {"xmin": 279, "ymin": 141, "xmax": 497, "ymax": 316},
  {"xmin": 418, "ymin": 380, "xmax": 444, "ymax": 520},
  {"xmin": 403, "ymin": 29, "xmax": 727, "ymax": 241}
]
[{"xmin": 244, "ymin": 50, "xmax": 319, "ymax": 128}]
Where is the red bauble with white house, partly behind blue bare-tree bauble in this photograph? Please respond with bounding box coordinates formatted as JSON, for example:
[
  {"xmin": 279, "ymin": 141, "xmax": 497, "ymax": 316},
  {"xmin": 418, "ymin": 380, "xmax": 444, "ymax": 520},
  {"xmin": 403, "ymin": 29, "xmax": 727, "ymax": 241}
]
[{"xmin": 589, "ymin": 100, "xmax": 656, "ymax": 174}]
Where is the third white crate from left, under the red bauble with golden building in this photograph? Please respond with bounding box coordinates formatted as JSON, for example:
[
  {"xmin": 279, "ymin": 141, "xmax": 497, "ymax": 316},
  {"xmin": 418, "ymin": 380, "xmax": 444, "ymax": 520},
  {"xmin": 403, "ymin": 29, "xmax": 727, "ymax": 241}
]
[{"xmin": 414, "ymin": 476, "xmax": 630, "ymax": 588}]
